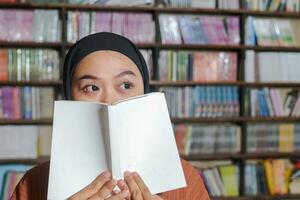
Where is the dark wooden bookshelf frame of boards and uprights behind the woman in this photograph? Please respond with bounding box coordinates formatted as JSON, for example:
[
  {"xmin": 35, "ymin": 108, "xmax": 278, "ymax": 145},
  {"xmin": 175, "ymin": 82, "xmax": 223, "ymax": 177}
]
[{"xmin": 0, "ymin": 1, "xmax": 300, "ymax": 200}]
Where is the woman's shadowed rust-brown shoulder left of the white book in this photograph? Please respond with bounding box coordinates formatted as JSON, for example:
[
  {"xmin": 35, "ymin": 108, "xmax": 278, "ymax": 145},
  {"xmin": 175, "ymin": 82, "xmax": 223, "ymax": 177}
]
[{"xmin": 11, "ymin": 162, "xmax": 50, "ymax": 200}]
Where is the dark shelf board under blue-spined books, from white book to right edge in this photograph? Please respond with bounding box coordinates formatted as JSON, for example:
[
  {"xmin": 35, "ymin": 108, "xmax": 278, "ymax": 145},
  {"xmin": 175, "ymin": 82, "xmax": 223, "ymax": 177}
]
[{"xmin": 171, "ymin": 117, "xmax": 300, "ymax": 124}]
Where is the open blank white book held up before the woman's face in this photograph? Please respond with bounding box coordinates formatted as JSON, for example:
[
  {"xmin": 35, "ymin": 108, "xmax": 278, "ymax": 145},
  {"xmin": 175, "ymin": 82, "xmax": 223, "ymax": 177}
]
[{"xmin": 48, "ymin": 93, "xmax": 186, "ymax": 200}]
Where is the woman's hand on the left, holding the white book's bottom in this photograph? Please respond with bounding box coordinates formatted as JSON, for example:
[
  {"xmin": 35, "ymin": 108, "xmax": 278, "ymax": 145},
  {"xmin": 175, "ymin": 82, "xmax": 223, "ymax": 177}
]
[{"xmin": 68, "ymin": 171, "xmax": 130, "ymax": 200}]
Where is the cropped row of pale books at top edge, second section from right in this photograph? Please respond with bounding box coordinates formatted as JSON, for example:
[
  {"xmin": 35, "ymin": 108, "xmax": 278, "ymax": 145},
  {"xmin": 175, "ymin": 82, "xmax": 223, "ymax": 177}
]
[{"xmin": 163, "ymin": 0, "xmax": 240, "ymax": 9}]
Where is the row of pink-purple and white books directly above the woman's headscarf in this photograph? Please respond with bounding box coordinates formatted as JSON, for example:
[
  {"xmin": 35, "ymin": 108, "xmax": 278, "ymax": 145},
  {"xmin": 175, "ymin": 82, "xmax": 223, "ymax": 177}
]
[{"xmin": 67, "ymin": 11, "xmax": 155, "ymax": 43}]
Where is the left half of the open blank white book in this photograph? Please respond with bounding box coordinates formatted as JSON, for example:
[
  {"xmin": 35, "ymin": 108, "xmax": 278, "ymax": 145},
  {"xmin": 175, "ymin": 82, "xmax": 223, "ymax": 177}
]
[{"xmin": 48, "ymin": 101, "xmax": 109, "ymax": 200}]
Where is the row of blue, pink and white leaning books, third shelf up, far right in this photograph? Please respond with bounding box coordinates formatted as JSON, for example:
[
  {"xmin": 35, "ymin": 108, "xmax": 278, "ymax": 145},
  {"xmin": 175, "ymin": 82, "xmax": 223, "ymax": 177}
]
[{"xmin": 245, "ymin": 87, "xmax": 300, "ymax": 117}]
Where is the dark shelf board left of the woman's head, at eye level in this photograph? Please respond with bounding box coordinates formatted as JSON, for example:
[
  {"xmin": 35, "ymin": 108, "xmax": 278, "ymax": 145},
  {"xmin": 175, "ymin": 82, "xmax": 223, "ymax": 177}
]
[{"xmin": 0, "ymin": 80, "xmax": 62, "ymax": 86}]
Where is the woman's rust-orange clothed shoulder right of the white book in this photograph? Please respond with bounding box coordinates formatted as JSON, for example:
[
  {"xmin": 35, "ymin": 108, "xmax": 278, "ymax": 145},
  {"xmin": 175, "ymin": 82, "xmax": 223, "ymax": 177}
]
[{"xmin": 162, "ymin": 159, "xmax": 209, "ymax": 200}]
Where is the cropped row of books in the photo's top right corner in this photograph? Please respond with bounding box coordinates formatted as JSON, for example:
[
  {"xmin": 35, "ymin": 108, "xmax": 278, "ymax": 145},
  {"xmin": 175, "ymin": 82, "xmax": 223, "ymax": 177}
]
[{"xmin": 245, "ymin": 0, "xmax": 300, "ymax": 12}]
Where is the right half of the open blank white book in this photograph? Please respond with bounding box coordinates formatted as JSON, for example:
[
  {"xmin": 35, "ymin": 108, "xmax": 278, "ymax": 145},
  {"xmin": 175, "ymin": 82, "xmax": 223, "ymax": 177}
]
[{"xmin": 109, "ymin": 93, "xmax": 186, "ymax": 194}]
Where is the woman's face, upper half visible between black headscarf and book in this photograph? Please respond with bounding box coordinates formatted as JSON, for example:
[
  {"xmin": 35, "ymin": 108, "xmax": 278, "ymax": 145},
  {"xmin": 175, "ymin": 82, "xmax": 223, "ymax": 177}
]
[{"xmin": 71, "ymin": 50, "xmax": 144, "ymax": 104}]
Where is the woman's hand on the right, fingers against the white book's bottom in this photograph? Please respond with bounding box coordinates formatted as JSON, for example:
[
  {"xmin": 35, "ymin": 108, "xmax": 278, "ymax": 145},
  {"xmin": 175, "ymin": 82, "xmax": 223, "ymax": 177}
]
[{"xmin": 118, "ymin": 172, "xmax": 163, "ymax": 200}]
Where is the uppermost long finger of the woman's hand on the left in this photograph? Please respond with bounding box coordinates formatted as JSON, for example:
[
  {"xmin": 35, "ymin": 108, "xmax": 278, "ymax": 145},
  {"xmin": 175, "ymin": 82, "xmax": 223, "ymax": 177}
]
[{"xmin": 70, "ymin": 171, "xmax": 111, "ymax": 199}]
